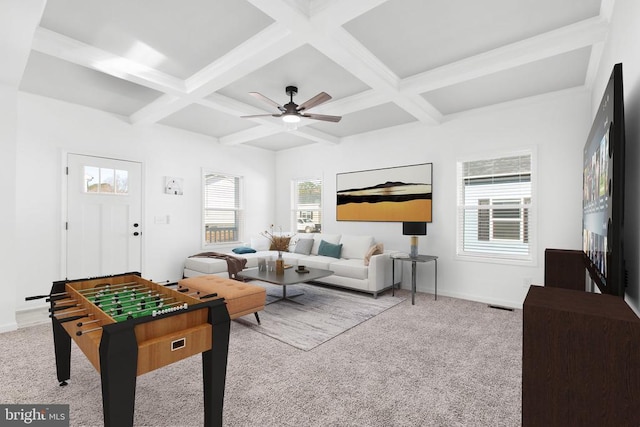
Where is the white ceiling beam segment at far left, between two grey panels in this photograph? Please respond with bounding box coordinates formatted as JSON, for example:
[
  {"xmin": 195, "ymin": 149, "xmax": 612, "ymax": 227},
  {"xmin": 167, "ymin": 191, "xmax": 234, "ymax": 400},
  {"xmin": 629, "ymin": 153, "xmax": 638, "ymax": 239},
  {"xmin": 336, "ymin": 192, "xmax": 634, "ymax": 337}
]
[{"xmin": 32, "ymin": 27, "xmax": 185, "ymax": 95}]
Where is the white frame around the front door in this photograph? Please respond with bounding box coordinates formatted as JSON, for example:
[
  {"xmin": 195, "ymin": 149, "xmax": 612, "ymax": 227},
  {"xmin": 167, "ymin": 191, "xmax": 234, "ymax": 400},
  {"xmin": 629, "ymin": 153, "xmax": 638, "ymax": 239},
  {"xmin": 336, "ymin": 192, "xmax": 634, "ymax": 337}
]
[{"xmin": 59, "ymin": 150, "xmax": 147, "ymax": 278}]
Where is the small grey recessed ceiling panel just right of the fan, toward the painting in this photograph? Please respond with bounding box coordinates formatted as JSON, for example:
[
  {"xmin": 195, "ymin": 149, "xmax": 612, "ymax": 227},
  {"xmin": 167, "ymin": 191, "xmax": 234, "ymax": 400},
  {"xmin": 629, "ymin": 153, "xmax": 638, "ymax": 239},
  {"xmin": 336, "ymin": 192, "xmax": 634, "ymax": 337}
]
[{"xmin": 310, "ymin": 103, "xmax": 416, "ymax": 137}]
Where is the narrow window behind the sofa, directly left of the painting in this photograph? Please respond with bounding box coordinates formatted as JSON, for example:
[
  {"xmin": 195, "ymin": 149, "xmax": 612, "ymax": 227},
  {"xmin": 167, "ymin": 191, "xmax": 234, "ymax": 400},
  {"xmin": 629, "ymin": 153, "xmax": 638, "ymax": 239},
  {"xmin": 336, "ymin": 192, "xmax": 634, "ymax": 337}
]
[{"xmin": 292, "ymin": 179, "xmax": 322, "ymax": 233}]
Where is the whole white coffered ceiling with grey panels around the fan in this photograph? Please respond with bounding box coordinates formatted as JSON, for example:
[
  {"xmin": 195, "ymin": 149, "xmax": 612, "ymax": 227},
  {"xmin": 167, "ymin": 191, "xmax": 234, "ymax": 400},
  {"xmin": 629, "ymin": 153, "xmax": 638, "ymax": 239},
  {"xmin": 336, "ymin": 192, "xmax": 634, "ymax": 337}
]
[{"xmin": 19, "ymin": 0, "xmax": 613, "ymax": 151}]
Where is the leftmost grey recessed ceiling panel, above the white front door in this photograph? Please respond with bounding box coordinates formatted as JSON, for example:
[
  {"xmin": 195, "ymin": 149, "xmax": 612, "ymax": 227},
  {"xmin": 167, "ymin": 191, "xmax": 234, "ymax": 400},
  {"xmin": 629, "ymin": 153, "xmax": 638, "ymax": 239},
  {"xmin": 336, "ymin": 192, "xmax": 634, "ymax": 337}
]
[{"xmin": 20, "ymin": 51, "xmax": 161, "ymax": 116}]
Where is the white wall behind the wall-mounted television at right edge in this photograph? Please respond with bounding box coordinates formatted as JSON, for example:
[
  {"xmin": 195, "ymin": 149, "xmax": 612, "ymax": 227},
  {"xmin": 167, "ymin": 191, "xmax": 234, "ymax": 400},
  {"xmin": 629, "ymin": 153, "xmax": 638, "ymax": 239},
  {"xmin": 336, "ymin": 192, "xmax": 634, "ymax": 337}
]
[{"xmin": 591, "ymin": 0, "xmax": 640, "ymax": 314}]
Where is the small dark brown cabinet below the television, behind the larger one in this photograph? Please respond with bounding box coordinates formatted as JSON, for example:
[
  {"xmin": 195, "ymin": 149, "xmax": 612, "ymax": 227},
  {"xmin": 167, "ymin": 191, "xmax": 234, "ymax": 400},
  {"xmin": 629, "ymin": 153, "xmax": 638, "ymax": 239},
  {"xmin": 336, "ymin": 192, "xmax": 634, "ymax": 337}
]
[{"xmin": 544, "ymin": 249, "xmax": 587, "ymax": 291}]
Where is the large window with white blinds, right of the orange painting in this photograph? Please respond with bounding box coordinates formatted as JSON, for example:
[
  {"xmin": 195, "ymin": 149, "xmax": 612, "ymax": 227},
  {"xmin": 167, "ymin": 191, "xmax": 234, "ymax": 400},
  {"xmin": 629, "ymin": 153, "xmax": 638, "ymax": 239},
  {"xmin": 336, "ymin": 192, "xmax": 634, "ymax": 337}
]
[{"xmin": 458, "ymin": 153, "xmax": 532, "ymax": 261}]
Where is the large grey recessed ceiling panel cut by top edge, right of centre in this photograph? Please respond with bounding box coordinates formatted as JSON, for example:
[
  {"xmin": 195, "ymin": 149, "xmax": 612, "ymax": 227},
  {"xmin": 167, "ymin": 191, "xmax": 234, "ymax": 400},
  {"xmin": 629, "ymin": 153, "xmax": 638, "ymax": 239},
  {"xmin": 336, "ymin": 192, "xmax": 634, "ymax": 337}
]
[{"xmin": 344, "ymin": 0, "xmax": 601, "ymax": 78}]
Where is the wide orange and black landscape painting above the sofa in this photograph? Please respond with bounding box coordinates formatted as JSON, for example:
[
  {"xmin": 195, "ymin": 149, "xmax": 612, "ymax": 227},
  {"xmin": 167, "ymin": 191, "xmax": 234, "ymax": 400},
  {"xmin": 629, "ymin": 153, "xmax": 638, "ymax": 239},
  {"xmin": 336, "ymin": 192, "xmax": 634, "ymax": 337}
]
[{"xmin": 336, "ymin": 163, "xmax": 433, "ymax": 222}]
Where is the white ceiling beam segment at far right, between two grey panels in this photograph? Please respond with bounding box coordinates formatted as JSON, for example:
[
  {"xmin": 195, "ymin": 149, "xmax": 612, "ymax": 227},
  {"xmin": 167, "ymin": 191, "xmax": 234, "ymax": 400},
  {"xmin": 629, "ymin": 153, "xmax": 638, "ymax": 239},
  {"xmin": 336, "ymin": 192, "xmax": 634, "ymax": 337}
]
[{"xmin": 400, "ymin": 17, "xmax": 608, "ymax": 93}]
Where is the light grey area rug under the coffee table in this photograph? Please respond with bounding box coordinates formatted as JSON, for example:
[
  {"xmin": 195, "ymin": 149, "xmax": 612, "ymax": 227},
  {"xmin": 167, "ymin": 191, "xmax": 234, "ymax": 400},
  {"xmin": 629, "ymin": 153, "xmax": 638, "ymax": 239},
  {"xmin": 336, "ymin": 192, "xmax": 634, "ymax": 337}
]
[{"xmin": 237, "ymin": 281, "xmax": 405, "ymax": 351}]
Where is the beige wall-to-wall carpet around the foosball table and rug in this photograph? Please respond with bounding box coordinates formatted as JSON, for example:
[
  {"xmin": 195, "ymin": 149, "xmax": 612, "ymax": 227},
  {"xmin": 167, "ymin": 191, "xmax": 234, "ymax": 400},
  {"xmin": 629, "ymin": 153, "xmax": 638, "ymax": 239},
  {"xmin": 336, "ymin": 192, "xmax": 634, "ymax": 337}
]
[{"xmin": 0, "ymin": 291, "xmax": 522, "ymax": 427}]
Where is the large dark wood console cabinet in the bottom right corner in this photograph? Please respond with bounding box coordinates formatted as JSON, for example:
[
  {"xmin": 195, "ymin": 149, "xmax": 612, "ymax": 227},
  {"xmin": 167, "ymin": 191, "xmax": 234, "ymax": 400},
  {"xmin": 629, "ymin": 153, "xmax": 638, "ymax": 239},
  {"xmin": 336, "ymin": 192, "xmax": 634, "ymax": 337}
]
[{"xmin": 522, "ymin": 286, "xmax": 640, "ymax": 427}]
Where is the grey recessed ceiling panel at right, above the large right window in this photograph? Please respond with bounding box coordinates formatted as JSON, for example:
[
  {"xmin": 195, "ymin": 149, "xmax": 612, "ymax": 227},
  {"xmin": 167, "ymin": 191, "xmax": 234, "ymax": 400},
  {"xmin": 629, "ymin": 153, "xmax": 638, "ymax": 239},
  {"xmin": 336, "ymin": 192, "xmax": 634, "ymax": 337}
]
[{"xmin": 422, "ymin": 48, "xmax": 591, "ymax": 114}]
